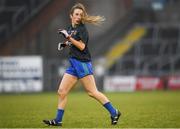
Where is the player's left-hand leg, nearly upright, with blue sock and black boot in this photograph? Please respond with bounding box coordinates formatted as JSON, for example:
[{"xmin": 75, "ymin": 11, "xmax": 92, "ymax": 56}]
[{"xmin": 43, "ymin": 73, "xmax": 77, "ymax": 126}]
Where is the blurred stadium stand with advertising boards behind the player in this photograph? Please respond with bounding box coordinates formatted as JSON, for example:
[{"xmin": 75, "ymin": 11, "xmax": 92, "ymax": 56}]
[{"xmin": 0, "ymin": 0, "xmax": 180, "ymax": 93}]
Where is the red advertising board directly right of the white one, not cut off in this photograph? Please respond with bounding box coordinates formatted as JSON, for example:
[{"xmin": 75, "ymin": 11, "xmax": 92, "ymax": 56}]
[{"xmin": 136, "ymin": 77, "xmax": 163, "ymax": 90}]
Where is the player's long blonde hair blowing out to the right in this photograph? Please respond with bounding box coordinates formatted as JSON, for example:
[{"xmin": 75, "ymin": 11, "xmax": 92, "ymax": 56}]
[{"xmin": 70, "ymin": 3, "xmax": 105, "ymax": 25}]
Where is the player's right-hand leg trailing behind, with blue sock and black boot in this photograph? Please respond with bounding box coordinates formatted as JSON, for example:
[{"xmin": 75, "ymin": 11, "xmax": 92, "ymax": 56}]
[{"xmin": 80, "ymin": 75, "xmax": 121, "ymax": 124}]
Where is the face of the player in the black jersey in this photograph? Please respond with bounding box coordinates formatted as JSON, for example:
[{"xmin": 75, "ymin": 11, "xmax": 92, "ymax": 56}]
[{"xmin": 70, "ymin": 9, "xmax": 83, "ymax": 25}]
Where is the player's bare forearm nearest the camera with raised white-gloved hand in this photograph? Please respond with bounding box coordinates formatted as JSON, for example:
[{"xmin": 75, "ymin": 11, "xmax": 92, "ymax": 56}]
[{"xmin": 58, "ymin": 30, "xmax": 85, "ymax": 51}]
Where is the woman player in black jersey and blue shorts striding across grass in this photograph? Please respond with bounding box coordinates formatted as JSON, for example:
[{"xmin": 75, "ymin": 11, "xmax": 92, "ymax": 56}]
[{"xmin": 43, "ymin": 3, "xmax": 121, "ymax": 126}]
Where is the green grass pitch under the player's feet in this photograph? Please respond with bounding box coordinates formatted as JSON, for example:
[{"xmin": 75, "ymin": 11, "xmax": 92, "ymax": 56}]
[{"xmin": 0, "ymin": 91, "xmax": 180, "ymax": 128}]
